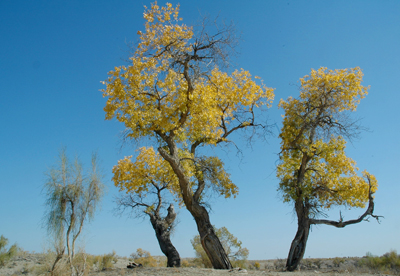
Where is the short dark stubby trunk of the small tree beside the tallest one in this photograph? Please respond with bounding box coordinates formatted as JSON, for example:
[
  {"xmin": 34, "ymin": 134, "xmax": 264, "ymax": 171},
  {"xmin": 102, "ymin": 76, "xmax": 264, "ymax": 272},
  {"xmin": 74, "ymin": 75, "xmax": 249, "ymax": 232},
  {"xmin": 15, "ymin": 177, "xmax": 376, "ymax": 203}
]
[{"xmin": 150, "ymin": 204, "xmax": 181, "ymax": 267}]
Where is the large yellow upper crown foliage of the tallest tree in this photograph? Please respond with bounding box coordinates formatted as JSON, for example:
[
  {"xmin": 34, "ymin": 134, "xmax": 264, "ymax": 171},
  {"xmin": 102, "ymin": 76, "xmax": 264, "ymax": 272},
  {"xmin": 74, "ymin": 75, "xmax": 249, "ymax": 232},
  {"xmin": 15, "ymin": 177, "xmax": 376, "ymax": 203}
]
[{"xmin": 103, "ymin": 1, "xmax": 274, "ymax": 144}]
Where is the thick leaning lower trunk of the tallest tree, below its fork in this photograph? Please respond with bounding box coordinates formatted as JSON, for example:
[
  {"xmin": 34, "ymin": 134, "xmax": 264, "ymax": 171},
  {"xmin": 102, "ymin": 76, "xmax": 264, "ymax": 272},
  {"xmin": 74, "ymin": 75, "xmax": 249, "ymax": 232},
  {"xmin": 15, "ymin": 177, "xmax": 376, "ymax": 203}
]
[{"xmin": 191, "ymin": 203, "xmax": 232, "ymax": 269}]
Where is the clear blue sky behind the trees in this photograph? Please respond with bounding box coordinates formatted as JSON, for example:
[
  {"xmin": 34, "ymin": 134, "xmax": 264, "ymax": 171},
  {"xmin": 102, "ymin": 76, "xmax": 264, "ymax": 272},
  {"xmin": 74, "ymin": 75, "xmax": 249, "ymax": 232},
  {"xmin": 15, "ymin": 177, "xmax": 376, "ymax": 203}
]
[{"xmin": 0, "ymin": 0, "xmax": 400, "ymax": 259}]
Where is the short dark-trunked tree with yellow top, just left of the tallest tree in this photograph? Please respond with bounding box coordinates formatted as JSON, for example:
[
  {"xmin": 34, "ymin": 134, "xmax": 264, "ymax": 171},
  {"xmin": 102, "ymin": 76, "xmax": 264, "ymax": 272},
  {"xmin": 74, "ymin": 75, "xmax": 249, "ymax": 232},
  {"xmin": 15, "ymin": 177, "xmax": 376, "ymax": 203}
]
[{"xmin": 113, "ymin": 147, "xmax": 182, "ymax": 267}]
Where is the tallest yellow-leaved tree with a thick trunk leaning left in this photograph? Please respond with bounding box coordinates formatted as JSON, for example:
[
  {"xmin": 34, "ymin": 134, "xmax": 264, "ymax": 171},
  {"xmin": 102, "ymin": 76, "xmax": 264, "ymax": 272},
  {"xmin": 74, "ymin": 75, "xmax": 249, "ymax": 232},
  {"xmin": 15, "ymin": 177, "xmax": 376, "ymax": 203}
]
[{"xmin": 103, "ymin": 3, "xmax": 274, "ymax": 269}]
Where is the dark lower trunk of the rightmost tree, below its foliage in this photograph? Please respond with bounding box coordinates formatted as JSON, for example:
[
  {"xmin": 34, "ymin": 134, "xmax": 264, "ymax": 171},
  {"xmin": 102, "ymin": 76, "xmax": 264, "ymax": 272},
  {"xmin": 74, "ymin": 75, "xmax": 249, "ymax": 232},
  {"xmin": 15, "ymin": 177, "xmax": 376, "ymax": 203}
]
[{"xmin": 286, "ymin": 199, "xmax": 310, "ymax": 271}]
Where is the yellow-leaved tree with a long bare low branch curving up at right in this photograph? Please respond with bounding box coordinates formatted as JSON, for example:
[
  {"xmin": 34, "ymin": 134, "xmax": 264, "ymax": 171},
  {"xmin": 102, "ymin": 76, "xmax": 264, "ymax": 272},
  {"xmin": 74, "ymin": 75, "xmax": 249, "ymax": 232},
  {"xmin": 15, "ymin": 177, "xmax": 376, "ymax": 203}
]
[{"xmin": 277, "ymin": 67, "xmax": 379, "ymax": 271}]
